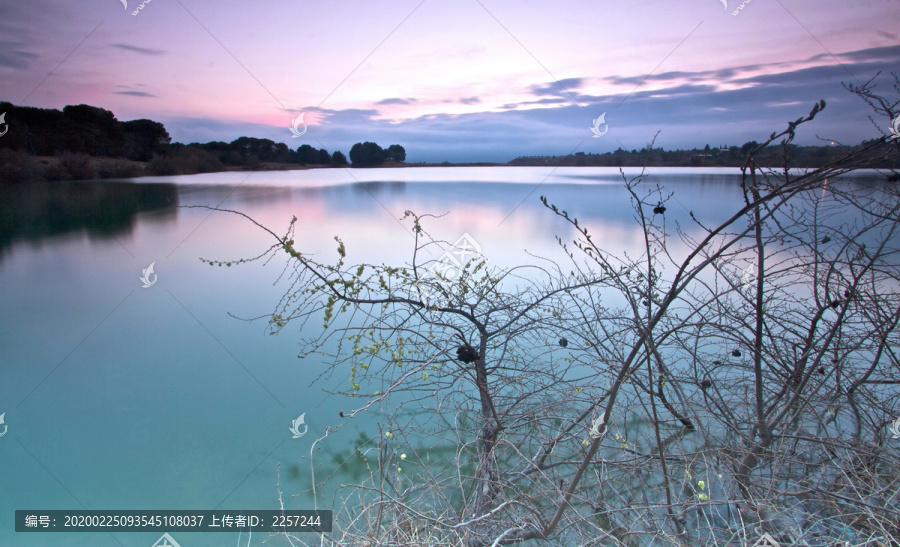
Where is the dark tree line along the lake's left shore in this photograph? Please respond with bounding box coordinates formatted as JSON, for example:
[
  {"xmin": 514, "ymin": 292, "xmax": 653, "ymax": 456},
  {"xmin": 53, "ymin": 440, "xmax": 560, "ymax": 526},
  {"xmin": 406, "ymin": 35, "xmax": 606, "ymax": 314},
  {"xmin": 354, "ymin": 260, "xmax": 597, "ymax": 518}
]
[{"xmin": 0, "ymin": 102, "xmax": 406, "ymax": 182}]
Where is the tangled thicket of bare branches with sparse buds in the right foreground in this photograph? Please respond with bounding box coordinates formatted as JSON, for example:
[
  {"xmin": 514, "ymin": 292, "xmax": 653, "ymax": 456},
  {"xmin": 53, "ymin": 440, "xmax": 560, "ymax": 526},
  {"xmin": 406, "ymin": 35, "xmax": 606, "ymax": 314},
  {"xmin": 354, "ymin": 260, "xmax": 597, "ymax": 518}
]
[{"xmin": 206, "ymin": 79, "xmax": 900, "ymax": 546}]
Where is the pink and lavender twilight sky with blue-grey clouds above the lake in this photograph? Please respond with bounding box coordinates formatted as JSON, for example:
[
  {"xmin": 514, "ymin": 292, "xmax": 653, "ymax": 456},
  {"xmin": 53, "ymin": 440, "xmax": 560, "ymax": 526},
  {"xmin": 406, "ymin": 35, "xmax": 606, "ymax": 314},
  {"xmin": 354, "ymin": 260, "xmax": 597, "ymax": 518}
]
[{"xmin": 0, "ymin": 0, "xmax": 900, "ymax": 162}]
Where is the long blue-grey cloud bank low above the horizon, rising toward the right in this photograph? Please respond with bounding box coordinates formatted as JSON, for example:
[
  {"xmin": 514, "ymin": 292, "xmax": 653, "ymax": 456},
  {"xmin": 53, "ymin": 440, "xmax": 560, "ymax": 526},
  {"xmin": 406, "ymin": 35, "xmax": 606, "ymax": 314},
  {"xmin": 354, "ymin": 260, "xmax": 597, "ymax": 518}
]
[{"xmin": 161, "ymin": 46, "xmax": 900, "ymax": 162}]
